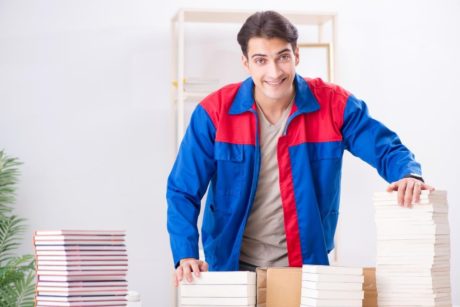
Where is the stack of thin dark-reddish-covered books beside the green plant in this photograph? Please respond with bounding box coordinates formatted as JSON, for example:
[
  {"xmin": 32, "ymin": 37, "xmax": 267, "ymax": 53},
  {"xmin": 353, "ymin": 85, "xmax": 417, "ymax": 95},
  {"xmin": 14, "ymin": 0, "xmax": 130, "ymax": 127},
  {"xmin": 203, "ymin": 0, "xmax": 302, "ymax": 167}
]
[{"xmin": 34, "ymin": 230, "xmax": 128, "ymax": 307}]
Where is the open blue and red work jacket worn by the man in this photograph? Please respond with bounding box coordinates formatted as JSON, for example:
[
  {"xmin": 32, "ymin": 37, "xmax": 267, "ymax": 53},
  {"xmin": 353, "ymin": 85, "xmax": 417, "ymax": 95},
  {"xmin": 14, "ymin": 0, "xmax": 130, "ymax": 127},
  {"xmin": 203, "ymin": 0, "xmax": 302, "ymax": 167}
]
[{"xmin": 167, "ymin": 75, "xmax": 421, "ymax": 271}]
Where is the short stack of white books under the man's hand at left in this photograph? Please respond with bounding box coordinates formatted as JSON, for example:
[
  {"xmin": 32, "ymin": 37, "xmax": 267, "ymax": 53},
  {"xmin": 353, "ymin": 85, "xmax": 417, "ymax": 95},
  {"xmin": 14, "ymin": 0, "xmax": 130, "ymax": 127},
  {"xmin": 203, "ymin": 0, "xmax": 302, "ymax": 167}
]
[{"xmin": 179, "ymin": 272, "xmax": 256, "ymax": 307}]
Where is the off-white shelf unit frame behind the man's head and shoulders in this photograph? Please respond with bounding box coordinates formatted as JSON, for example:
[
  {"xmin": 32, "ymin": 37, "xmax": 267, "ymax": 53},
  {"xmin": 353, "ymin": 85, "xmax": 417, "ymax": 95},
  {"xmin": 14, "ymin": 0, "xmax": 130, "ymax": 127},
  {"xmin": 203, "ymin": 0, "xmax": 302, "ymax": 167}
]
[{"xmin": 171, "ymin": 9, "xmax": 336, "ymax": 150}]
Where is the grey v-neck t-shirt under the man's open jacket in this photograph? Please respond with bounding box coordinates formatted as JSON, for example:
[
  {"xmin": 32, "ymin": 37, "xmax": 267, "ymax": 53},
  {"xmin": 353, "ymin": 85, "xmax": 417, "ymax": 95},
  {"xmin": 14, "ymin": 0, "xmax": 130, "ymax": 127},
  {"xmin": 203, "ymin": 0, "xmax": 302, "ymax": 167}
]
[{"xmin": 240, "ymin": 102, "xmax": 292, "ymax": 267}]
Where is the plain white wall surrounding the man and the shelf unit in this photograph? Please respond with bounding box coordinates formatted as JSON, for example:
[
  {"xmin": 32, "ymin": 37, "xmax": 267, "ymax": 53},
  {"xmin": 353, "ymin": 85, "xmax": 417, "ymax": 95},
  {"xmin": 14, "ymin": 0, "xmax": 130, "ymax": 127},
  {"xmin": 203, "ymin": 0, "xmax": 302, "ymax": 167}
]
[{"xmin": 0, "ymin": 0, "xmax": 460, "ymax": 306}]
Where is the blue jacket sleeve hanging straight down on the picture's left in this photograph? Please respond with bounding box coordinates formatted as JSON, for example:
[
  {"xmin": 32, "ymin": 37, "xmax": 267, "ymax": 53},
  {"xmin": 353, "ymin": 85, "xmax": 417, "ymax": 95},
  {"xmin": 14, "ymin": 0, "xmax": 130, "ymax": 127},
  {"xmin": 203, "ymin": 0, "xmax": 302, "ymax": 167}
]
[{"xmin": 166, "ymin": 105, "xmax": 216, "ymax": 267}]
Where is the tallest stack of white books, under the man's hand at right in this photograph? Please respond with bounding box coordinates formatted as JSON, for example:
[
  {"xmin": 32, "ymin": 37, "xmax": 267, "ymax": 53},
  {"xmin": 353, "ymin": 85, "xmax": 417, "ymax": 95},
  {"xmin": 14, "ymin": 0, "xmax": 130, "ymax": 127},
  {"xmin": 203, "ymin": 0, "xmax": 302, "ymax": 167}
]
[{"xmin": 374, "ymin": 191, "xmax": 451, "ymax": 306}]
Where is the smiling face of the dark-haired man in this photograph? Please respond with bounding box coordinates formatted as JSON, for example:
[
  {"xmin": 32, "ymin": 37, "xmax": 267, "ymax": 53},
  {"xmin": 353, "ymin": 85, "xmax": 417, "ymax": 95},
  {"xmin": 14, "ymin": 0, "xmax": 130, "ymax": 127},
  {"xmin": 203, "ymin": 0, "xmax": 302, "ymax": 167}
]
[{"xmin": 242, "ymin": 37, "xmax": 299, "ymax": 102}]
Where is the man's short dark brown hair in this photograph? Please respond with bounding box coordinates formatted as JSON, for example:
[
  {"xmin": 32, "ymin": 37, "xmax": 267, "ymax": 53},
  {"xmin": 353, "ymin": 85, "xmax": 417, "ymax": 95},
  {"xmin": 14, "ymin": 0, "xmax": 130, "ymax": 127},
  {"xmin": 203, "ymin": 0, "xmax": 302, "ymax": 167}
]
[{"xmin": 237, "ymin": 11, "xmax": 299, "ymax": 57}]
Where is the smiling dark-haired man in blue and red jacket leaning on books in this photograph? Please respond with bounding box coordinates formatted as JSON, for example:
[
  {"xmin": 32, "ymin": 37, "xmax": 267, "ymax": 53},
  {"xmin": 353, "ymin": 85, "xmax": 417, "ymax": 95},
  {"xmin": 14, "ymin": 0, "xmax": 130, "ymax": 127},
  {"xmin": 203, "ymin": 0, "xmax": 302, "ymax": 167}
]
[{"xmin": 167, "ymin": 11, "xmax": 433, "ymax": 285}]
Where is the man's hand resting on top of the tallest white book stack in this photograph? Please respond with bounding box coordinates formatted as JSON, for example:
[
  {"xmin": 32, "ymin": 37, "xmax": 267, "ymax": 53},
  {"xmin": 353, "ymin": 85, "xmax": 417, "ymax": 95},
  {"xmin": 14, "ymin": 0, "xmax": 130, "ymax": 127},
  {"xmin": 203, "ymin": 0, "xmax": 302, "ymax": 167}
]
[{"xmin": 387, "ymin": 178, "xmax": 434, "ymax": 208}]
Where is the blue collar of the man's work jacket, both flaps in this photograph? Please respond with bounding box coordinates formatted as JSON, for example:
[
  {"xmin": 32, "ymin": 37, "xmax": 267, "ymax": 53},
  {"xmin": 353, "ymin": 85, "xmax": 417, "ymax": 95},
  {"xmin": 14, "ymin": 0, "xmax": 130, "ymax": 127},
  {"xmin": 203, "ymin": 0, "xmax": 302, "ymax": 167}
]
[{"xmin": 229, "ymin": 74, "xmax": 319, "ymax": 115}]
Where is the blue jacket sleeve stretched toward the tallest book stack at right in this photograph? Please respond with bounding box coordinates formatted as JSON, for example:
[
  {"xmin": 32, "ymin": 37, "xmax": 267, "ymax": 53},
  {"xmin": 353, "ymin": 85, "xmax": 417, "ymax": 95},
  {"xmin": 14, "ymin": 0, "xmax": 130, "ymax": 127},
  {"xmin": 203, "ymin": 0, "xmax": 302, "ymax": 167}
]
[{"xmin": 342, "ymin": 95, "xmax": 422, "ymax": 182}]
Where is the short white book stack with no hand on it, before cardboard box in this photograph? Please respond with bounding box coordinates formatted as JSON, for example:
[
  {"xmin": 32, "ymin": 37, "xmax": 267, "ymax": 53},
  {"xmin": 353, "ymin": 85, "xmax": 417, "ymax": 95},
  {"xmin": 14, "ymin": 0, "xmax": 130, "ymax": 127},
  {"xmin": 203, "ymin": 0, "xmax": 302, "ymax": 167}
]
[{"xmin": 301, "ymin": 265, "xmax": 364, "ymax": 307}]
